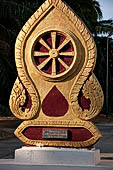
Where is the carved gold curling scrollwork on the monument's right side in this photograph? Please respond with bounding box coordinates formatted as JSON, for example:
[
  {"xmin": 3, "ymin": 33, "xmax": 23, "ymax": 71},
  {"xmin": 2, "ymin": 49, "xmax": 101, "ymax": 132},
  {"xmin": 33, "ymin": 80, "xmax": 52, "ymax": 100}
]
[{"xmin": 71, "ymin": 73, "xmax": 104, "ymax": 120}]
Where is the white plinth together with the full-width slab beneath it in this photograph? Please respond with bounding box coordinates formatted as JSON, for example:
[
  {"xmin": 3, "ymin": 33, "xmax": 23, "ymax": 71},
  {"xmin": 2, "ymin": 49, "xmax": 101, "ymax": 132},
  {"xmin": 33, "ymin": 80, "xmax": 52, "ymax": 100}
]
[{"xmin": 0, "ymin": 147, "xmax": 113, "ymax": 170}]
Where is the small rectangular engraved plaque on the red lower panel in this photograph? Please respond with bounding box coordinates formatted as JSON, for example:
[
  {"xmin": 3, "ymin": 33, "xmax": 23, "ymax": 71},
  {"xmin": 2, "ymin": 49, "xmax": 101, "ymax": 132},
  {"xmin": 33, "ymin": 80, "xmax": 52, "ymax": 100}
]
[{"xmin": 43, "ymin": 129, "xmax": 68, "ymax": 139}]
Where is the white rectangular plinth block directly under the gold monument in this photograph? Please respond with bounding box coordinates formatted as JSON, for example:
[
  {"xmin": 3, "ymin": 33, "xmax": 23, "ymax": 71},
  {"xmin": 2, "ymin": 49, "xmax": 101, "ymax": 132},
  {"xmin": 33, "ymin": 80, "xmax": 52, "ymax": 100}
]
[{"xmin": 15, "ymin": 147, "xmax": 100, "ymax": 166}]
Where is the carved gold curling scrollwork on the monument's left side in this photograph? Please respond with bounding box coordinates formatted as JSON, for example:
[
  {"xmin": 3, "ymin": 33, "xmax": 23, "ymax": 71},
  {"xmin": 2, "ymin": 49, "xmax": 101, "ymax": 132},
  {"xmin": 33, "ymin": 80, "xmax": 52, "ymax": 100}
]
[{"xmin": 10, "ymin": 77, "xmax": 38, "ymax": 120}]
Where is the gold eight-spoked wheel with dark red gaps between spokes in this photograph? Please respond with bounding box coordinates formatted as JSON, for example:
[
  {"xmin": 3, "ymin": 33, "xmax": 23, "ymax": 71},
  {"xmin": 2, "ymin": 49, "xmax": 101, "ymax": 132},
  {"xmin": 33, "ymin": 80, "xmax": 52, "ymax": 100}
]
[{"xmin": 33, "ymin": 31, "xmax": 76, "ymax": 78}]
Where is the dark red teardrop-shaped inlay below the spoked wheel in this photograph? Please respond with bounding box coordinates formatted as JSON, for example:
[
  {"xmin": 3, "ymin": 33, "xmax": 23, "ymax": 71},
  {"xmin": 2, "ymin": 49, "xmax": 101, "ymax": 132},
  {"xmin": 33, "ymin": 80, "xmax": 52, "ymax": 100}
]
[{"xmin": 42, "ymin": 86, "xmax": 69, "ymax": 117}]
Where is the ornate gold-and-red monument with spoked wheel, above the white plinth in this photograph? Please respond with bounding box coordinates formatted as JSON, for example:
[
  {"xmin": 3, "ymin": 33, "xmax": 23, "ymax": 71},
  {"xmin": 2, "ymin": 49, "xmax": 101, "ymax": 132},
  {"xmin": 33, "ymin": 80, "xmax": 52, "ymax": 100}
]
[{"xmin": 10, "ymin": 0, "xmax": 104, "ymax": 148}]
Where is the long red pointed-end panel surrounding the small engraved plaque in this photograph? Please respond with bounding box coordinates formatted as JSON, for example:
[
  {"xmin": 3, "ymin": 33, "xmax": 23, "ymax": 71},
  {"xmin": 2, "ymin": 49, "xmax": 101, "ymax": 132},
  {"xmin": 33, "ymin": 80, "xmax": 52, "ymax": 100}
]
[{"xmin": 22, "ymin": 126, "xmax": 93, "ymax": 142}]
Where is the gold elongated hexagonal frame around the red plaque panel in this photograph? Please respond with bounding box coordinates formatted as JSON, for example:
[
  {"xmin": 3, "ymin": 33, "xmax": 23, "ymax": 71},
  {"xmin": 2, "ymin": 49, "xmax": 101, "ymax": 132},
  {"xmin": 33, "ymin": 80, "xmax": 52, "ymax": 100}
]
[{"xmin": 14, "ymin": 120, "xmax": 102, "ymax": 147}]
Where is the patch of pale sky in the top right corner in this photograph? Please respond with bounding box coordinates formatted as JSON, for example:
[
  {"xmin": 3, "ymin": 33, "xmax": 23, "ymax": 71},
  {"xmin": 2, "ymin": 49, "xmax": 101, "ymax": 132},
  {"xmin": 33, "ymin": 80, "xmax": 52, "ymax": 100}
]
[{"xmin": 97, "ymin": 0, "xmax": 113, "ymax": 20}]
